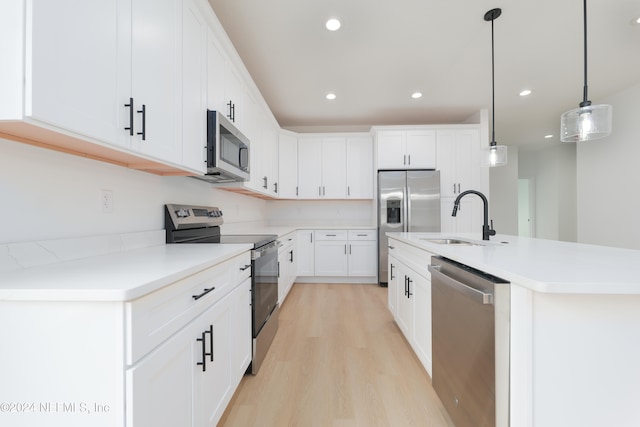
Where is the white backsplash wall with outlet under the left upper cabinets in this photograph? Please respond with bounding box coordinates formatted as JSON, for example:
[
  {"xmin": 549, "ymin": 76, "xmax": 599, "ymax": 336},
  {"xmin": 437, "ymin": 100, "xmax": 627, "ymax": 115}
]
[{"xmin": 0, "ymin": 139, "xmax": 266, "ymax": 244}]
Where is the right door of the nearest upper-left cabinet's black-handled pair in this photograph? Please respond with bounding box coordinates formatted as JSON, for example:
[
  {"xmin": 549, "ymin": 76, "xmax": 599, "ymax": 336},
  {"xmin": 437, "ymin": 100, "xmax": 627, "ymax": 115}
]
[{"xmin": 129, "ymin": 0, "xmax": 182, "ymax": 164}]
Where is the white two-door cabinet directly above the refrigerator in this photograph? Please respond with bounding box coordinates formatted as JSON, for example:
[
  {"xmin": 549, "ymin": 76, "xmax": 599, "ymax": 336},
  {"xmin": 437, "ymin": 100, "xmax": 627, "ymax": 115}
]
[{"xmin": 376, "ymin": 129, "xmax": 436, "ymax": 169}]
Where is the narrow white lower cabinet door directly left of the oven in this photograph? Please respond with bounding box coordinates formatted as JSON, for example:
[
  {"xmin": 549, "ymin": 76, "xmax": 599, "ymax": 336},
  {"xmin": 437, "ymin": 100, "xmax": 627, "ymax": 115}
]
[{"xmin": 230, "ymin": 278, "xmax": 253, "ymax": 382}]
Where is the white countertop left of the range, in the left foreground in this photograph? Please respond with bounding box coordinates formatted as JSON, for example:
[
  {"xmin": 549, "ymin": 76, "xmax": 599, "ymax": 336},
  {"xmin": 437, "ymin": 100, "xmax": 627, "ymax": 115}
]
[{"xmin": 0, "ymin": 244, "xmax": 252, "ymax": 301}]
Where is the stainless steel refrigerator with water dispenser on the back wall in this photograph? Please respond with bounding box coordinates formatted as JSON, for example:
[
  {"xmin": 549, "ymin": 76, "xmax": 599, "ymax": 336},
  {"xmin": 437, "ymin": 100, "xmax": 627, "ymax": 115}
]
[{"xmin": 378, "ymin": 170, "xmax": 440, "ymax": 286}]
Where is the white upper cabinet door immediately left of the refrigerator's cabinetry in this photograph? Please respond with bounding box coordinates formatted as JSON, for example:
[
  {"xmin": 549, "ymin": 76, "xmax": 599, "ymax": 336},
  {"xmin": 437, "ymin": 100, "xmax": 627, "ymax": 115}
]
[{"xmin": 346, "ymin": 136, "xmax": 374, "ymax": 199}]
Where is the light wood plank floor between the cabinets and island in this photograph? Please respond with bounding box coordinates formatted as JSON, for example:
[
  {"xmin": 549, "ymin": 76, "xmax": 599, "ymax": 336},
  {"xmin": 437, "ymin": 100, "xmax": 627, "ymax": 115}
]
[{"xmin": 219, "ymin": 283, "xmax": 453, "ymax": 427}]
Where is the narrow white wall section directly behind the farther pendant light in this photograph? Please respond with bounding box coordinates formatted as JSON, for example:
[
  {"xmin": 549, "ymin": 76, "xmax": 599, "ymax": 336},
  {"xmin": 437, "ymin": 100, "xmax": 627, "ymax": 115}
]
[{"xmin": 489, "ymin": 146, "xmax": 518, "ymax": 235}]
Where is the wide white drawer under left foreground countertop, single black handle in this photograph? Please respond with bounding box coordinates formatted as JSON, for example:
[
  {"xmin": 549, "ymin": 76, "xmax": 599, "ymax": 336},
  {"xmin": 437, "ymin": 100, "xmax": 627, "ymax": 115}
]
[{"xmin": 125, "ymin": 257, "xmax": 235, "ymax": 365}]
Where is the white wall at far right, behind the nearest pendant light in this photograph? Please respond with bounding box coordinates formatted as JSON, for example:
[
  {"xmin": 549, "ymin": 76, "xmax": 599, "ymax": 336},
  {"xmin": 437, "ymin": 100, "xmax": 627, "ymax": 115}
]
[{"xmin": 577, "ymin": 85, "xmax": 640, "ymax": 249}]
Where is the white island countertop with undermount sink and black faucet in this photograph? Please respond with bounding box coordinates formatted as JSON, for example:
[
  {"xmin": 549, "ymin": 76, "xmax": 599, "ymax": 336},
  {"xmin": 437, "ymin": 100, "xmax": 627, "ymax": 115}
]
[{"xmin": 387, "ymin": 233, "xmax": 640, "ymax": 294}]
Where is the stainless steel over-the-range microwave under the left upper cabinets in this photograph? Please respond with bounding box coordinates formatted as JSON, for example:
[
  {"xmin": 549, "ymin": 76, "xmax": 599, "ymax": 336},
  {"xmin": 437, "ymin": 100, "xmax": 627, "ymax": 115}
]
[{"xmin": 194, "ymin": 110, "xmax": 249, "ymax": 183}]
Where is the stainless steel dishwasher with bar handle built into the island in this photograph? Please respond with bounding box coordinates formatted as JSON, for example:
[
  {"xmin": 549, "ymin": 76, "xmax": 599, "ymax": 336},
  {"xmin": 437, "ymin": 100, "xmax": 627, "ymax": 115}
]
[{"xmin": 429, "ymin": 257, "xmax": 510, "ymax": 427}]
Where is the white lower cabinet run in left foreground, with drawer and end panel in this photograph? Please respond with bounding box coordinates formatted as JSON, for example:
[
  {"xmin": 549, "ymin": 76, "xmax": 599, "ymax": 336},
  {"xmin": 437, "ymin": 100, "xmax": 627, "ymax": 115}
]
[{"xmin": 0, "ymin": 252, "xmax": 252, "ymax": 427}]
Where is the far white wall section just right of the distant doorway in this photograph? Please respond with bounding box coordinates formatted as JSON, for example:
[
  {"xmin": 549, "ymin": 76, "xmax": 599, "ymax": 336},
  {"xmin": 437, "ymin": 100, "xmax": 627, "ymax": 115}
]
[{"xmin": 518, "ymin": 144, "xmax": 577, "ymax": 242}]
